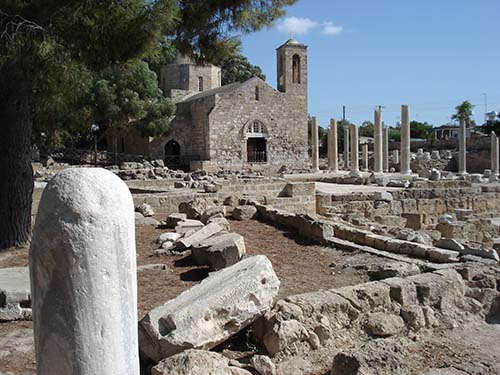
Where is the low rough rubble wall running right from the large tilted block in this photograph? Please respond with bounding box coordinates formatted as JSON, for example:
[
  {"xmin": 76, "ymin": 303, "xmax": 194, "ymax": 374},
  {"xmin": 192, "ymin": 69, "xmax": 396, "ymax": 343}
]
[{"xmin": 252, "ymin": 270, "xmax": 498, "ymax": 357}]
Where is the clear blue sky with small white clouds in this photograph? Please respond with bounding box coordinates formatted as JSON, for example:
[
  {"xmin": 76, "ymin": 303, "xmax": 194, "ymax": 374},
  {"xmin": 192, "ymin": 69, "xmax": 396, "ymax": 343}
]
[{"xmin": 242, "ymin": 0, "xmax": 500, "ymax": 126}]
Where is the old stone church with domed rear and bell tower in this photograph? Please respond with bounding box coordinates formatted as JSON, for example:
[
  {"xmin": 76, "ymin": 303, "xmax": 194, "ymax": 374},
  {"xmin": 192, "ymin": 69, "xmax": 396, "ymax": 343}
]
[{"xmin": 109, "ymin": 39, "xmax": 309, "ymax": 171}]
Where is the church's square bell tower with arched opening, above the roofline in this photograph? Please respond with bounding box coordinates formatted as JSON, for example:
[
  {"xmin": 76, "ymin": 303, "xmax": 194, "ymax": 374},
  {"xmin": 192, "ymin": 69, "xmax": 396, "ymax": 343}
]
[{"xmin": 276, "ymin": 39, "xmax": 307, "ymax": 99}]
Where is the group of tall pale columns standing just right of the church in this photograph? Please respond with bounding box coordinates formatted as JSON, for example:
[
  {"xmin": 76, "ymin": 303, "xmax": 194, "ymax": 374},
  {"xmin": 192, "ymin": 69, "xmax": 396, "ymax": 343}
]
[{"xmin": 322, "ymin": 105, "xmax": 411, "ymax": 176}]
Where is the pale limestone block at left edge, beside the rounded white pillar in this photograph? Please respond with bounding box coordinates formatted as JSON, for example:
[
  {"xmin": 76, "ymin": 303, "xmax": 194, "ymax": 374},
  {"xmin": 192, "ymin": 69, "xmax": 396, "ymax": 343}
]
[{"xmin": 0, "ymin": 267, "xmax": 31, "ymax": 322}]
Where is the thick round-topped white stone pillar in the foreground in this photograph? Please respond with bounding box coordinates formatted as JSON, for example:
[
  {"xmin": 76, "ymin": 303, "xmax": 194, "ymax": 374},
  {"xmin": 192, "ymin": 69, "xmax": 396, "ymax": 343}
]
[{"xmin": 29, "ymin": 168, "xmax": 139, "ymax": 375}]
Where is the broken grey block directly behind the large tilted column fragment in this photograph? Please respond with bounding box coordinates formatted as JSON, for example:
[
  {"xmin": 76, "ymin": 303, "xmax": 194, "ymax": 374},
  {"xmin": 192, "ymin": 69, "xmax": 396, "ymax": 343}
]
[{"xmin": 191, "ymin": 233, "xmax": 246, "ymax": 271}]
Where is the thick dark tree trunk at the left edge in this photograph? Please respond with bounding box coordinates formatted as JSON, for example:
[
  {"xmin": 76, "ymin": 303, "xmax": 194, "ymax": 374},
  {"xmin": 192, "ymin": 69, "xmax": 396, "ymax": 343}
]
[{"xmin": 0, "ymin": 84, "xmax": 34, "ymax": 250}]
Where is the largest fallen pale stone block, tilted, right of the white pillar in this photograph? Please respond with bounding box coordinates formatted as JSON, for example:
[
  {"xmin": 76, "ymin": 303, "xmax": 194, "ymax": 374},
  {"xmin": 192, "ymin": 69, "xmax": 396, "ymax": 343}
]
[{"xmin": 139, "ymin": 255, "xmax": 280, "ymax": 361}]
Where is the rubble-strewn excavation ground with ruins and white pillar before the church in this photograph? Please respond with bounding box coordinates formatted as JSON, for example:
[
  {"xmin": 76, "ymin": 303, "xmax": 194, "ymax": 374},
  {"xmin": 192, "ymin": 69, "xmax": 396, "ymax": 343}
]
[{"xmin": 0, "ymin": 152, "xmax": 500, "ymax": 375}]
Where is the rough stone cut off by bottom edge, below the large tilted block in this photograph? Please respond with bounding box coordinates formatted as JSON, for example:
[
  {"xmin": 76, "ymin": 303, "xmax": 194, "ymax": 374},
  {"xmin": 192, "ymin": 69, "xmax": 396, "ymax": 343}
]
[{"xmin": 151, "ymin": 349, "xmax": 251, "ymax": 375}]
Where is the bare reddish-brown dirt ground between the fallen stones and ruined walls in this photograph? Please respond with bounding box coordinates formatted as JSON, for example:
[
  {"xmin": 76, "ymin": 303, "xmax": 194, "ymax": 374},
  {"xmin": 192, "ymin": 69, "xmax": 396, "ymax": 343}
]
[{"xmin": 0, "ymin": 220, "xmax": 500, "ymax": 375}]
